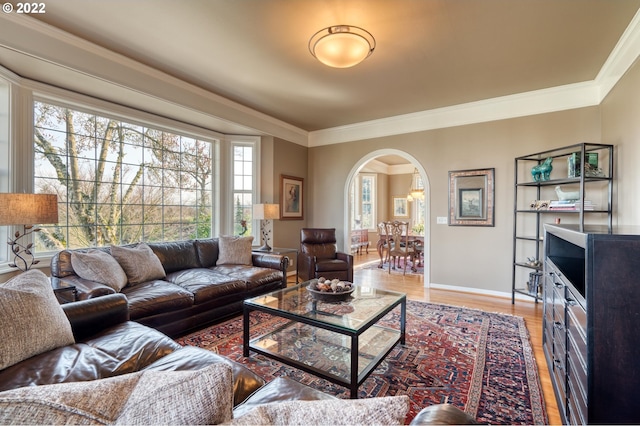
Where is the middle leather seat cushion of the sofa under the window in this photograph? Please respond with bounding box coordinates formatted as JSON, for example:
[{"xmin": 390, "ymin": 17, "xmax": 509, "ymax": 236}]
[{"xmin": 166, "ymin": 268, "xmax": 247, "ymax": 304}]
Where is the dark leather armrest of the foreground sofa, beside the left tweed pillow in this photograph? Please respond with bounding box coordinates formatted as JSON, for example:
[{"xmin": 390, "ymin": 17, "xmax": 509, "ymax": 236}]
[{"xmin": 61, "ymin": 293, "xmax": 129, "ymax": 342}]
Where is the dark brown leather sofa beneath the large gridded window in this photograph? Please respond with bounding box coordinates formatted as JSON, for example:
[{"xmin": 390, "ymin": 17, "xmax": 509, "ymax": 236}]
[{"xmin": 51, "ymin": 238, "xmax": 288, "ymax": 336}]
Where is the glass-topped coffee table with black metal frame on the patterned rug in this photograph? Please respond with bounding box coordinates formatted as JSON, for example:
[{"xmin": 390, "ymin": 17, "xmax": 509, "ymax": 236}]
[{"xmin": 243, "ymin": 281, "xmax": 407, "ymax": 398}]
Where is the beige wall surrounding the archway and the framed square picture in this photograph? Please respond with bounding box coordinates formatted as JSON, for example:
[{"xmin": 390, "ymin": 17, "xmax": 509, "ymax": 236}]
[{"xmin": 308, "ymin": 107, "xmax": 601, "ymax": 293}]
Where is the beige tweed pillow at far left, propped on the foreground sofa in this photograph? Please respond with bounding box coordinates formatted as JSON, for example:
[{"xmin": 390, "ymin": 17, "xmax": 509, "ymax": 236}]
[{"xmin": 0, "ymin": 269, "xmax": 75, "ymax": 370}]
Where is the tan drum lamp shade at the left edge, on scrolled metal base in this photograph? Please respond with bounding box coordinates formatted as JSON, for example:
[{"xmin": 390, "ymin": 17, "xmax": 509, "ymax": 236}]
[{"xmin": 0, "ymin": 193, "xmax": 58, "ymax": 225}]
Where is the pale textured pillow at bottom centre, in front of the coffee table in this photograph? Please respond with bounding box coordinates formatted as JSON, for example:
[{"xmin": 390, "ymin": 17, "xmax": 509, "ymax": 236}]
[{"xmin": 231, "ymin": 395, "xmax": 409, "ymax": 425}]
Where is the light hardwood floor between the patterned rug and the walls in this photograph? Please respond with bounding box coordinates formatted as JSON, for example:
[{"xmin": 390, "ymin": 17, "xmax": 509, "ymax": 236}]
[{"xmin": 292, "ymin": 249, "xmax": 562, "ymax": 425}]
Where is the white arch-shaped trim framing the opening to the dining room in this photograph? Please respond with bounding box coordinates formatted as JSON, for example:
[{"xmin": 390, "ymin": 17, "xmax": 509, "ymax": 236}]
[{"xmin": 343, "ymin": 148, "xmax": 431, "ymax": 287}]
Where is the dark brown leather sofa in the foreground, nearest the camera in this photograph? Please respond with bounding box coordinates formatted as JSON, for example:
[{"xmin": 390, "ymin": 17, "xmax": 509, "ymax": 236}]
[{"xmin": 0, "ymin": 294, "xmax": 473, "ymax": 424}]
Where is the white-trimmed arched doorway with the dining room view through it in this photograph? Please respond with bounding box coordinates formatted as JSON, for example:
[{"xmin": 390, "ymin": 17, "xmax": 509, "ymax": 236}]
[{"xmin": 344, "ymin": 149, "xmax": 430, "ymax": 286}]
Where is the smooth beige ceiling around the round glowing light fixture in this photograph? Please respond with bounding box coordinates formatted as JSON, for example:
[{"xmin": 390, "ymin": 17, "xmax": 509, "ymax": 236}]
[{"xmin": 5, "ymin": 0, "xmax": 640, "ymax": 131}]
